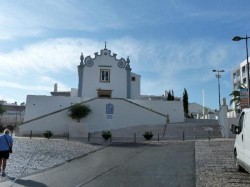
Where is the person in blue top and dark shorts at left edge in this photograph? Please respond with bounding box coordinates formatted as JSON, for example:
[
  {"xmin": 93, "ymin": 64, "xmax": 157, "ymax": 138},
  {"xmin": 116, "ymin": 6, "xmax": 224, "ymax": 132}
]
[{"xmin": 0, "ymin": 129, "xmax": 13, "ymax": 177}]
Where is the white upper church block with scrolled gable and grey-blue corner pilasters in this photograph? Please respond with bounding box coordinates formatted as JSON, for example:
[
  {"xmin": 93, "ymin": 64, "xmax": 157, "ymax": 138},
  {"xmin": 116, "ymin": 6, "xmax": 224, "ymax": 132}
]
[{"xmin": 78, "ymin": 46, "xmax": 140, "ymax": 99}]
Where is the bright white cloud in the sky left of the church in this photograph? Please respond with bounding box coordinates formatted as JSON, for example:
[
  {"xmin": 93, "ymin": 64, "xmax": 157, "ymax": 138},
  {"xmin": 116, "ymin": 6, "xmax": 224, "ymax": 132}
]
[{"xmin": 0, "ymin": 39, "xmax": 94, "ymax": 76}]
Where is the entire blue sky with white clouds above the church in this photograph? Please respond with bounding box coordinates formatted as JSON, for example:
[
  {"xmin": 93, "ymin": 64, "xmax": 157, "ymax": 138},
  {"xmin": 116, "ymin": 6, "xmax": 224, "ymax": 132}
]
[{"xmin": 0, "ymin": 0, "xmax": 250, "ymax": 109}]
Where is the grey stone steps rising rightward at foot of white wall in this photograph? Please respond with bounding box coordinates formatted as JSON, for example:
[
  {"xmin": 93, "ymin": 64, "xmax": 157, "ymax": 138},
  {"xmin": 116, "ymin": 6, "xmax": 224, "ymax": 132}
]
[{"xmin": 91, "ymin": 120, "xmax": 222, "ymax": 141}]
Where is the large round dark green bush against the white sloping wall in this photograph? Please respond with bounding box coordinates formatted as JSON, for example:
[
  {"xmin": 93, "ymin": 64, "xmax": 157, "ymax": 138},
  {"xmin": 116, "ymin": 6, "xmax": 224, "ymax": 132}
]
[{"xmin": 69, "ymin": 103, "xmax": 91, "ymax": 122}]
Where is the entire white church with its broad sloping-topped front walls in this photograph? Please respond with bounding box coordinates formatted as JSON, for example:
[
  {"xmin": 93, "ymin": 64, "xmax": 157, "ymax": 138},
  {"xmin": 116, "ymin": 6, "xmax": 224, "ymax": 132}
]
[{"xmin": 19, "ymin": 45, "xmax": 184, "ymax": 137}]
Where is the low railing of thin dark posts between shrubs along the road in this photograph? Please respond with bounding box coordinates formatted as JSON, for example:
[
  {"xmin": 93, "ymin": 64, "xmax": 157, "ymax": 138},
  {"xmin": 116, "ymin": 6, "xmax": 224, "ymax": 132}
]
[{"xmin": 17, "ymin": 124, "xmax": 224, "ymax": 144}]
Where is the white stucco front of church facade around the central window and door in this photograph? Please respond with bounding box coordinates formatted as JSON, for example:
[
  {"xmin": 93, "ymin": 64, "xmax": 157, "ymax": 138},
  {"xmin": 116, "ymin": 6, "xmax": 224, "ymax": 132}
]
[{"xmin": 82, "ymin": 50, "xmax": 127, "ymax": 98}]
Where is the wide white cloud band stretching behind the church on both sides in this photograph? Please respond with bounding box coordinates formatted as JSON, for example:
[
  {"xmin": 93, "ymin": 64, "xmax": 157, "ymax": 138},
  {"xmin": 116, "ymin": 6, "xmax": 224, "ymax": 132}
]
[{"xmin": 0, "ymin": 37, "xmax": 240, "ymax": 104}]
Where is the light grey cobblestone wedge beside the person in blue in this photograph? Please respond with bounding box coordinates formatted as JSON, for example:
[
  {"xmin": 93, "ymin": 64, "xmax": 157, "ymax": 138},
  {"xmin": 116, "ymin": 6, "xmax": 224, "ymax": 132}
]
[{"xmin": 3, "ymin": 137, "xmax": 103, "ymax": 178}]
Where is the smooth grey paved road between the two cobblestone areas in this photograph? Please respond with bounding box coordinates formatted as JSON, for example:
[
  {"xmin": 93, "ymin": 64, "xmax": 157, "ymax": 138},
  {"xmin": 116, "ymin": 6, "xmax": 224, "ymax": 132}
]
[{"xmin": 0, "ymin": 142, "xmax": 195, "ymax": 187}]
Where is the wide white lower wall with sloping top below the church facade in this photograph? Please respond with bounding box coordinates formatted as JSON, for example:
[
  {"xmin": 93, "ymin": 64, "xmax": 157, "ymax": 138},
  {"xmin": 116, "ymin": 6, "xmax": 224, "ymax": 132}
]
[{"xmin": 19, "ymin": 96, "xmax": 184, "ymax": 137}]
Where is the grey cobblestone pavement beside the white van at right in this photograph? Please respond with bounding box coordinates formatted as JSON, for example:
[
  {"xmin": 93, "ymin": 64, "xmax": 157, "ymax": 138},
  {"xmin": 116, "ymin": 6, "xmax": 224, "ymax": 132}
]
[{"xmin": 195, "ymin": 140, "xmax": 250, "ymax": 187}]
